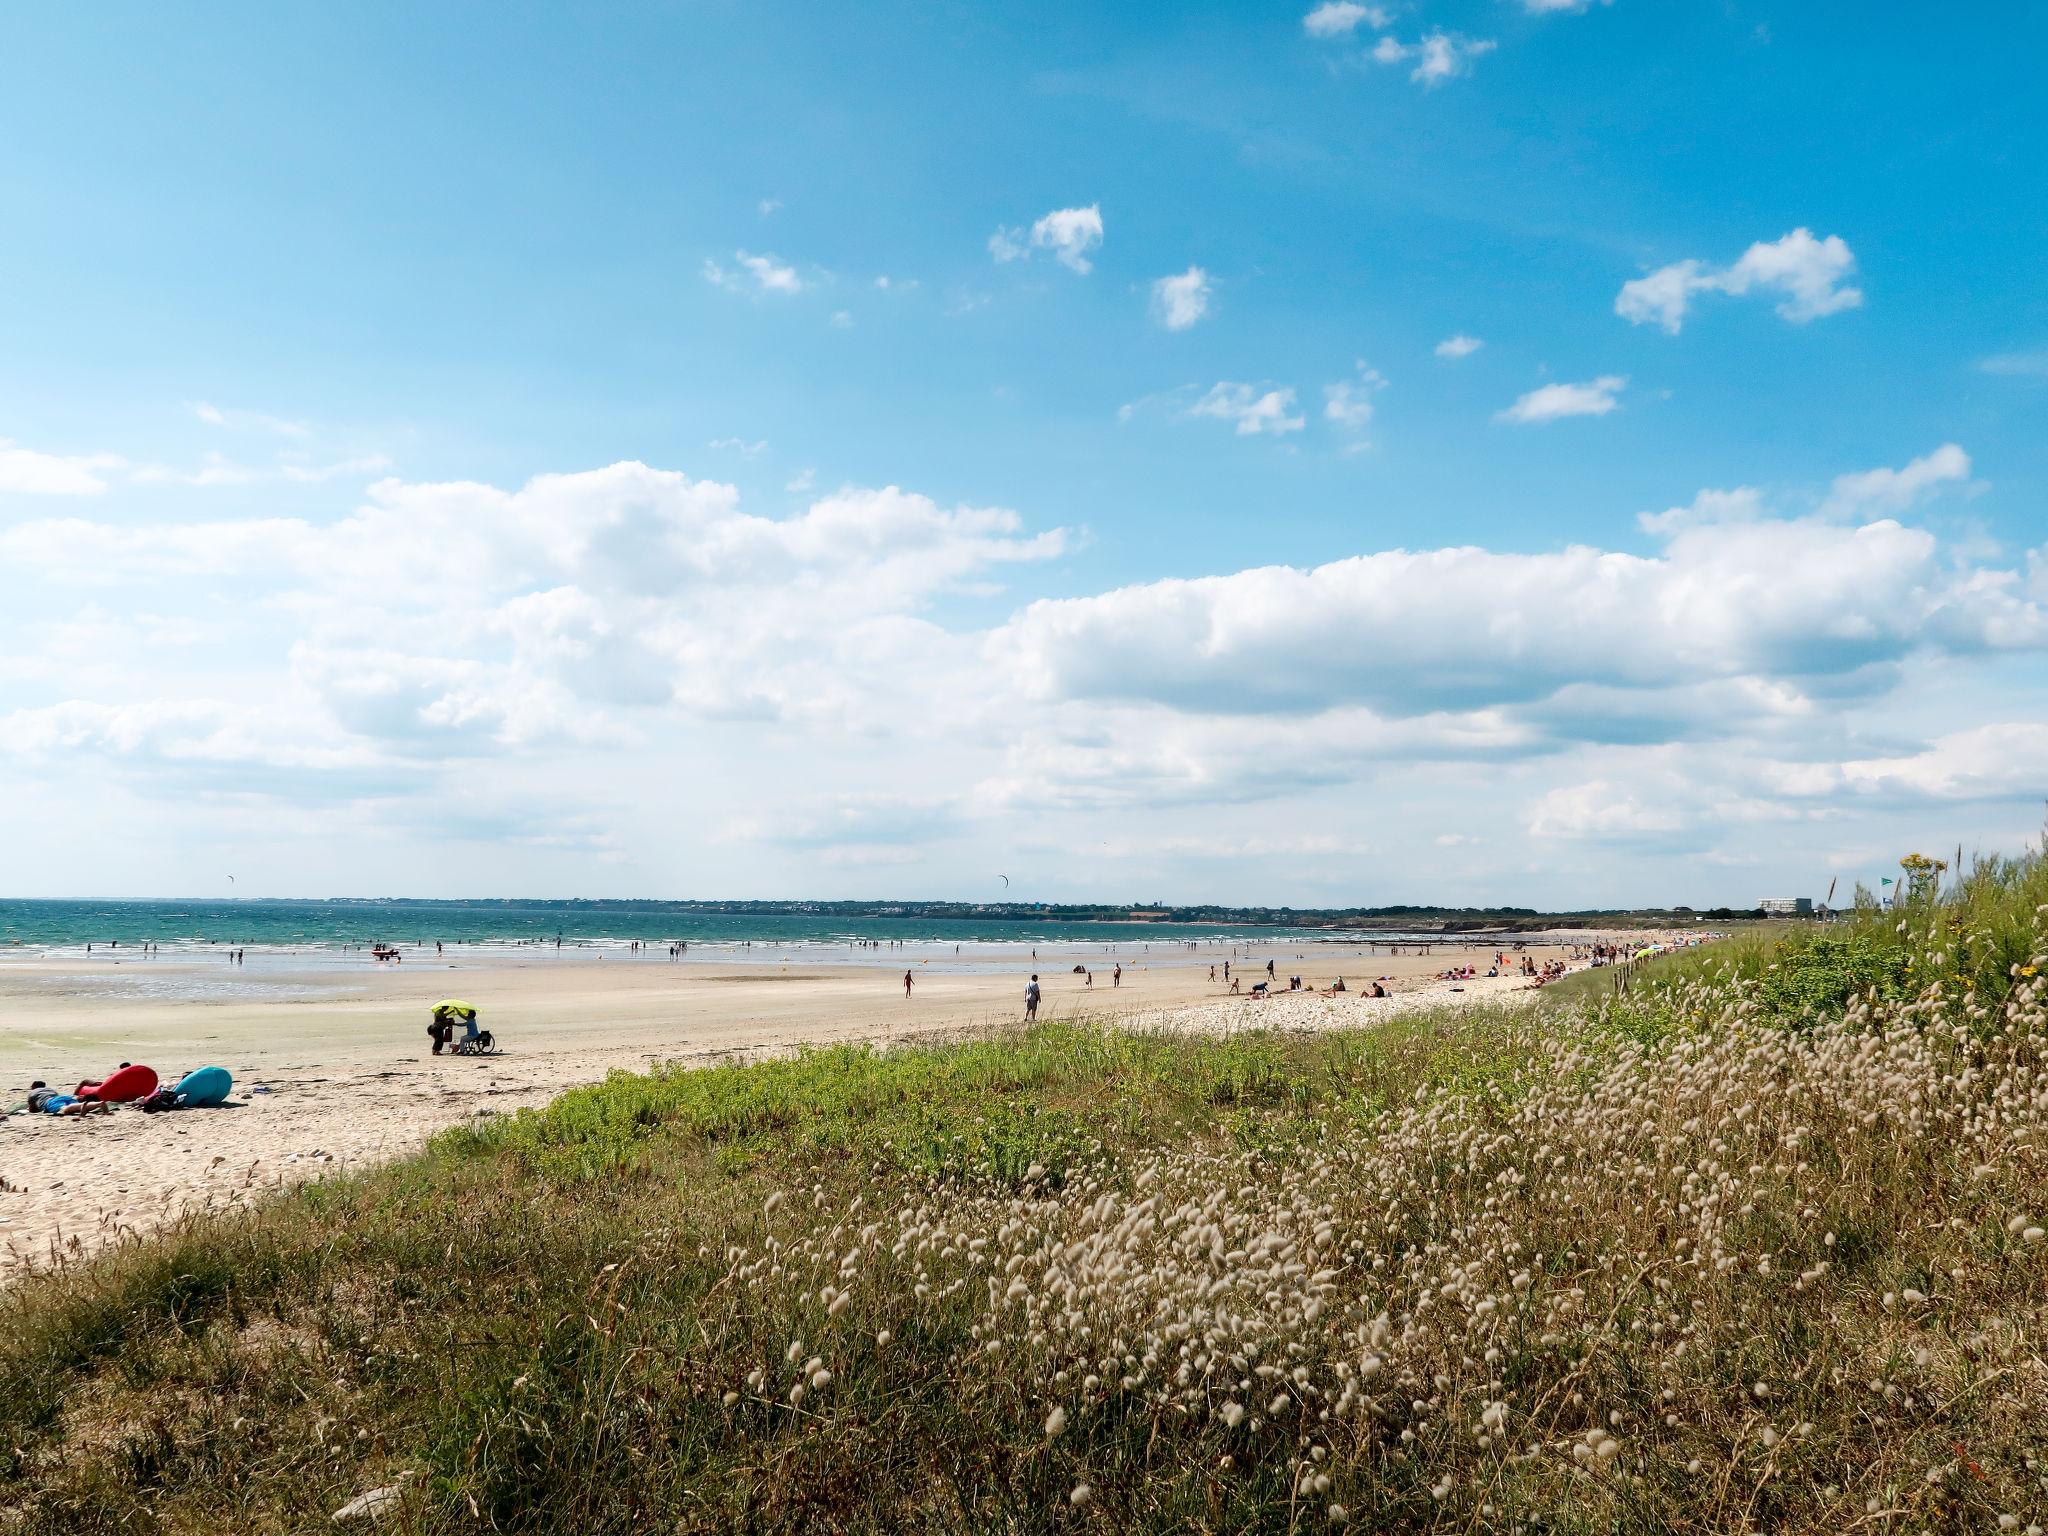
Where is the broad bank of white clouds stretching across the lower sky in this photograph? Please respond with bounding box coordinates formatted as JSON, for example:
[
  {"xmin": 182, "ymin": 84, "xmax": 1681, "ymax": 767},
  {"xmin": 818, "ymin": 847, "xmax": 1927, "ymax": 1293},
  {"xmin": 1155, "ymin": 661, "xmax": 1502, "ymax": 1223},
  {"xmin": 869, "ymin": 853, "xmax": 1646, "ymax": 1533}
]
[{"xmin": 0, "ymin": 438, "xmax": 2048, "ymax": 879}]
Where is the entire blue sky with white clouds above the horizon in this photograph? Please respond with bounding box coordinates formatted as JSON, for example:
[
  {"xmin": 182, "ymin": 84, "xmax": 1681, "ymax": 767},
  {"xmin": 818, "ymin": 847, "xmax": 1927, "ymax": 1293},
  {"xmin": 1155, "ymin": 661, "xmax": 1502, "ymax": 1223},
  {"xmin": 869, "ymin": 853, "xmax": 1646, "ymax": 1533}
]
[{"xmin": 0, "ymin": 0, "xmax": 2048, "ymax": 905}]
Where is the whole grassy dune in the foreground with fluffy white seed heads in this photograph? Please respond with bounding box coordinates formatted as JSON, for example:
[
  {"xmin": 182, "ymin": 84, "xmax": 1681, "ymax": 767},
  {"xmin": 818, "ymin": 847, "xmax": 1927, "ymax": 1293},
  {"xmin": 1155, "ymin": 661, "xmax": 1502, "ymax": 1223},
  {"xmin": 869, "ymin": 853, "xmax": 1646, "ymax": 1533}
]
[{"xmin": 0, "ymin": 860, "xmax": 2048, "ymax": 1532}]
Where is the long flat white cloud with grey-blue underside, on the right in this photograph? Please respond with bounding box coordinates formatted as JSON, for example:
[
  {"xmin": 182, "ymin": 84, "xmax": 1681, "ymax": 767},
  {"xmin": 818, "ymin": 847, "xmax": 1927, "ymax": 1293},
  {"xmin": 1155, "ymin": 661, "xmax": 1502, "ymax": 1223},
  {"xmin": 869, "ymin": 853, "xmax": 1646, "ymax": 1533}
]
[{"xmin": 989, "ymin": 518, "xmax": 2048, "ymax": 717}]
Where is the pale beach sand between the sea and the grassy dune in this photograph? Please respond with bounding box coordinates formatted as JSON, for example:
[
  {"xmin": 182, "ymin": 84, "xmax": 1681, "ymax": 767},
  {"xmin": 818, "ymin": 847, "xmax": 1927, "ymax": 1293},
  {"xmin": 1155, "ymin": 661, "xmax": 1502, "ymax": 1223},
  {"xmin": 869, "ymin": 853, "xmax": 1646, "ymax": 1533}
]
[{"xmin": 0, "ymin": 936, "xmax": 1577, "ymax": 1274}]
